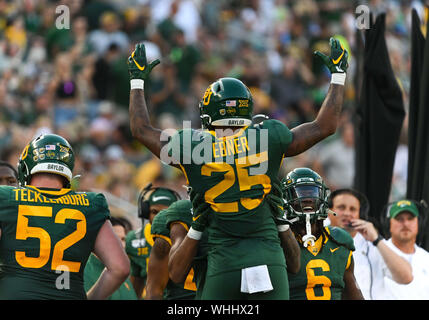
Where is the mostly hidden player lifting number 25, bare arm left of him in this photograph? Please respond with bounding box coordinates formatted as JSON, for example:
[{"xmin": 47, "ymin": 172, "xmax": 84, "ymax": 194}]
[{"xmin": 148, "ymin": 200, "xmax": 200, "ymax": 300}]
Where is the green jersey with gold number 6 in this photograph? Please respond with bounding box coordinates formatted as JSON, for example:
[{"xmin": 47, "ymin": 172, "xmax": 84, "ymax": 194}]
[{"xmin": 289, "ymin": 226, "xmax": 355, "ymax": 300}]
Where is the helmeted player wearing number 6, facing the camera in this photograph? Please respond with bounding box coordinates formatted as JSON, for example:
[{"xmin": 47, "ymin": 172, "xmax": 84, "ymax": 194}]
[{"xmin": 282, "ymin": 168, "xmax": 363, "ymax": 300}]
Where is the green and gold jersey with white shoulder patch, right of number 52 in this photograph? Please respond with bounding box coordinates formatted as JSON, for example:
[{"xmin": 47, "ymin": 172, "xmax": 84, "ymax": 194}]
[{"xmin": 125, "ymin": 223, "xmax": 153, "ymax": 298}]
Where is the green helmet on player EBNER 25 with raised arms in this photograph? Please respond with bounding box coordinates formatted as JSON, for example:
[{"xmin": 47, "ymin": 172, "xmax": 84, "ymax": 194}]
[{"xmin": 199, "ymin": 78, "xmax": 253, "ymax": 129}]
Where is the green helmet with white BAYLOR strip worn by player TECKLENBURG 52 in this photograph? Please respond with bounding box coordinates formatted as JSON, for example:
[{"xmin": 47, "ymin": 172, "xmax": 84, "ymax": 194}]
[{"xmin": 18, "ymin": 134, "xmax": 75, "ymax": 187}]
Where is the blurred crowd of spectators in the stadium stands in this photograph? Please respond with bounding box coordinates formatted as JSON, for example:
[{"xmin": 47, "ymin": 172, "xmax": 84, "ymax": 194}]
[{"xmin": 0, "ymin": 0, "xmax": 425, "ymax": 228}]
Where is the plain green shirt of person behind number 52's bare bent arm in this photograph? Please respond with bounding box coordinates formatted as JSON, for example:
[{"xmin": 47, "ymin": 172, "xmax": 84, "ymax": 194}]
[{"xmin": 84, "ymin": 254, "xmax": 137, "ymax": 300}]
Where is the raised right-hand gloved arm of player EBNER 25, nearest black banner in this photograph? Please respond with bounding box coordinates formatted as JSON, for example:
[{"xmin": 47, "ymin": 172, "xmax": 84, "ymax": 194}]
[{"xmin": 285, "ymin": 38, "xmax": 348, "ymax": 157}]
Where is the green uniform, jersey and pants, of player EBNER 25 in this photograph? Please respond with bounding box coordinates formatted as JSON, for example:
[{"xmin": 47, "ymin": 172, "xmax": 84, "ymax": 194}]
[{"xmin": 169, "ymin": 120, "xmax": 292, "ymax": 299}]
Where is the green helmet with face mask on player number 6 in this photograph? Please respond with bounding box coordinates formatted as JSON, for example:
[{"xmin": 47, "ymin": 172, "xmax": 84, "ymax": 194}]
[{"xmin": 282, "ymin": 168, "xmax": 330, "ymax": 223}]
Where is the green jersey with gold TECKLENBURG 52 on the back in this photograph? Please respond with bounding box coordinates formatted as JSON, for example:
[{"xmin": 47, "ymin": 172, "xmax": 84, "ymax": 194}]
[{"xmin": 0, "ymin": 186, "xmax": 110, "ymax": 299}]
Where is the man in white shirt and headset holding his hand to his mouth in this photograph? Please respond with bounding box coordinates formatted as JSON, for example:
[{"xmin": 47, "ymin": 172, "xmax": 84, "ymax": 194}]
[{"xmin": 329, "ymin": 188, "xmax": 413, "ymax": 300}]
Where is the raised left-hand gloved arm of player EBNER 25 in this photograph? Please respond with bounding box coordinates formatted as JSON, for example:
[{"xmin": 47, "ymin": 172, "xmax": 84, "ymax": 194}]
[{"xmin": 128, "ymin": 43, "xmax": 163, "ymax": 158}]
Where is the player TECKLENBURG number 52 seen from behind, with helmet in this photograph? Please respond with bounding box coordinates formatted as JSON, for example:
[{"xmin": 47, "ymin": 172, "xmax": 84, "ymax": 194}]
[{"xmin": 0, "ymin": 134, "xmax": 129, "ymax": 299}]
